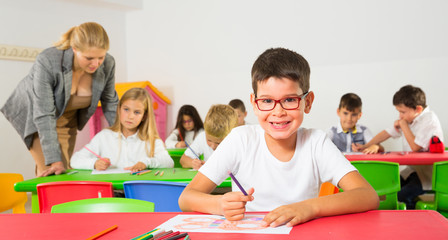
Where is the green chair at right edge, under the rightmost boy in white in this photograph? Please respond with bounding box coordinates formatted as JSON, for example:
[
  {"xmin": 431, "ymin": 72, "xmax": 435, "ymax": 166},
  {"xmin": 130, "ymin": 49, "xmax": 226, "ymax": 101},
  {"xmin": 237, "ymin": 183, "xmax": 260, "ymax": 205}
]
[{"xmin": 415, "ymin": 161, "xmax": 448, "ymax": 218}]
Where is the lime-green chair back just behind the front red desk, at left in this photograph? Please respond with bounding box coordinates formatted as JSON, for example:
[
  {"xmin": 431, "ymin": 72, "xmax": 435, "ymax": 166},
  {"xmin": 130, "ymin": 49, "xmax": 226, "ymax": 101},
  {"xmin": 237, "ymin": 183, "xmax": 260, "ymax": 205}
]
[{"xmin": 51, "ymin": 197, "xmax": 154, "ymax": 213}]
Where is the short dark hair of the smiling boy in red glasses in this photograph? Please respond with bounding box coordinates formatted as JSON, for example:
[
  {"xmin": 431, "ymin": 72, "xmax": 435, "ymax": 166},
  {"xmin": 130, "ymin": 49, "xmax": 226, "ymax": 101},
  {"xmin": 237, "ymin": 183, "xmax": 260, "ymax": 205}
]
[{"xmin": 252, "ymin": 48, "xmax": 310, "ymax": 96}]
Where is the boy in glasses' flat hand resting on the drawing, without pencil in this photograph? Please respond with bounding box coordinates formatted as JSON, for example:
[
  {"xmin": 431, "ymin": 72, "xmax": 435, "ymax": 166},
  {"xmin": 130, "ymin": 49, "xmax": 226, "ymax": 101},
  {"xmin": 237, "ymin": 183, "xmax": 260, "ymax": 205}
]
[{"xmin": 262, "ymin": 202, "xmax": 316, "ymax": 227}]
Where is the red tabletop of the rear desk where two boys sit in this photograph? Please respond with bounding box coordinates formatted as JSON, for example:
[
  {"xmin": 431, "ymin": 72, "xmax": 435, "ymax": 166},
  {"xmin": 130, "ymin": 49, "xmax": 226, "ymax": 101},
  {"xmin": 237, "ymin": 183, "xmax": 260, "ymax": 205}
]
[{"xmin": 345, "ymin": 152, "xmax": 448, "ymax": 165}]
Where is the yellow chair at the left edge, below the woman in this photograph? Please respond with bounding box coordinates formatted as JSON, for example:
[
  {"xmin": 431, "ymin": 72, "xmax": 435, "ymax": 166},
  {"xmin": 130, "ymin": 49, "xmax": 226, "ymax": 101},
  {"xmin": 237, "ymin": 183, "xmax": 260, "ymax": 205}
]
[{"xmin": 0, "ymin": 173, "xmax": 28, "ymax": 213}]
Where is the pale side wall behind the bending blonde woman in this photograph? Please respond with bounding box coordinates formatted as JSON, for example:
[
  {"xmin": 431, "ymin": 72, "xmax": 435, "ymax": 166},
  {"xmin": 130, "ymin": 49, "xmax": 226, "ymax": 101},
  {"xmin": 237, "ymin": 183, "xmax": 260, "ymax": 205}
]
[{"xmin": 0, "ymin": 0, "xmax": 127, "ymax": 179}]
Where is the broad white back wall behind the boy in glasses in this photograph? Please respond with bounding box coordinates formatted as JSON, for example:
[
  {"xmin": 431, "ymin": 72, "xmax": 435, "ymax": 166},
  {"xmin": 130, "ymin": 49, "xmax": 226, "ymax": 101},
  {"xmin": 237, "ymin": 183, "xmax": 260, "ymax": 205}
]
[{"xmin": 127, "ymin": 0, "xmax": 448, "ymax": 150}]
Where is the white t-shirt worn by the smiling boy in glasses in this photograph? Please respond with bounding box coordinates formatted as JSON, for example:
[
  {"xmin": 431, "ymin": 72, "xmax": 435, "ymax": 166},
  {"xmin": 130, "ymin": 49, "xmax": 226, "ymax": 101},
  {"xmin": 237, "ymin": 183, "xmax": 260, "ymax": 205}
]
[{"xmin": 199, "ymin": 125, "xmax": 356, "ymax": 211}]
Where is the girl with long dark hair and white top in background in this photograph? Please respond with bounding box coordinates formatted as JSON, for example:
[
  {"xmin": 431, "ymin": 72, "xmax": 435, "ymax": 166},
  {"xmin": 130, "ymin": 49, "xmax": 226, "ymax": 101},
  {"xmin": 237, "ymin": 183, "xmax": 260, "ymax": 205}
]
[{"xmin": 165, "ymin": 105, "xmax": 204, "ymax": 148}]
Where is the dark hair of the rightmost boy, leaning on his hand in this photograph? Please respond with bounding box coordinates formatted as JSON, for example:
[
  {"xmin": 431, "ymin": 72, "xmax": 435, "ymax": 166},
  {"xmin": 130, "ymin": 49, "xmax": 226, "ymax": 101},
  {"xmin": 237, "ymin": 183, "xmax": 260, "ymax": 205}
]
[{"xmin": 392, "ymin": 85, "xmax": 426, "ymax": 109}]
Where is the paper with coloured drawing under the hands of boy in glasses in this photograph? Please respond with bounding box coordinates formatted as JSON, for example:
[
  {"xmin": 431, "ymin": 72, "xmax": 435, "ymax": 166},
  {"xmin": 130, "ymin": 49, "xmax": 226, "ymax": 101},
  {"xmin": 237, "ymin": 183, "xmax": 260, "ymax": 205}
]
[{"xmin": 158, "ymin": 214, "xmax": 292, "ymax": 234}]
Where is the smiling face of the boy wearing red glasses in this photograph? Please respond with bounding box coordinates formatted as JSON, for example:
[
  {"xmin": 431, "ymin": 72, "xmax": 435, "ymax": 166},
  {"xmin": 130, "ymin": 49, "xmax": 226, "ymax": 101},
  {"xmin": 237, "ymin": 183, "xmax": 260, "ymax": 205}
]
[{"xmin": 251, "ymin": 77, "xmax": 314, "ymax": 143}]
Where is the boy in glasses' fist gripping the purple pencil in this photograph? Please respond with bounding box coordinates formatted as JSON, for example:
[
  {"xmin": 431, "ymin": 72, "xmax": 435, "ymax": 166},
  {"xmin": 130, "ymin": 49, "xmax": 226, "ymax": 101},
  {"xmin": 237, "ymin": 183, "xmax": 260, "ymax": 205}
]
[{"xmin": 220, "ymin": 188, "xmax": 254, "ymax": 221}]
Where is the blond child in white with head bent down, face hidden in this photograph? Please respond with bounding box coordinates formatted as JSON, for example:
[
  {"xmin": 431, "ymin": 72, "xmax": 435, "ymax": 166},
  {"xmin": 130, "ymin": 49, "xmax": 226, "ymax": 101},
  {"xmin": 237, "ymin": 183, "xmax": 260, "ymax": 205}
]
[{"xmin": 180, "ymin": 104, "xmax": 238, "ymax": 169}]
